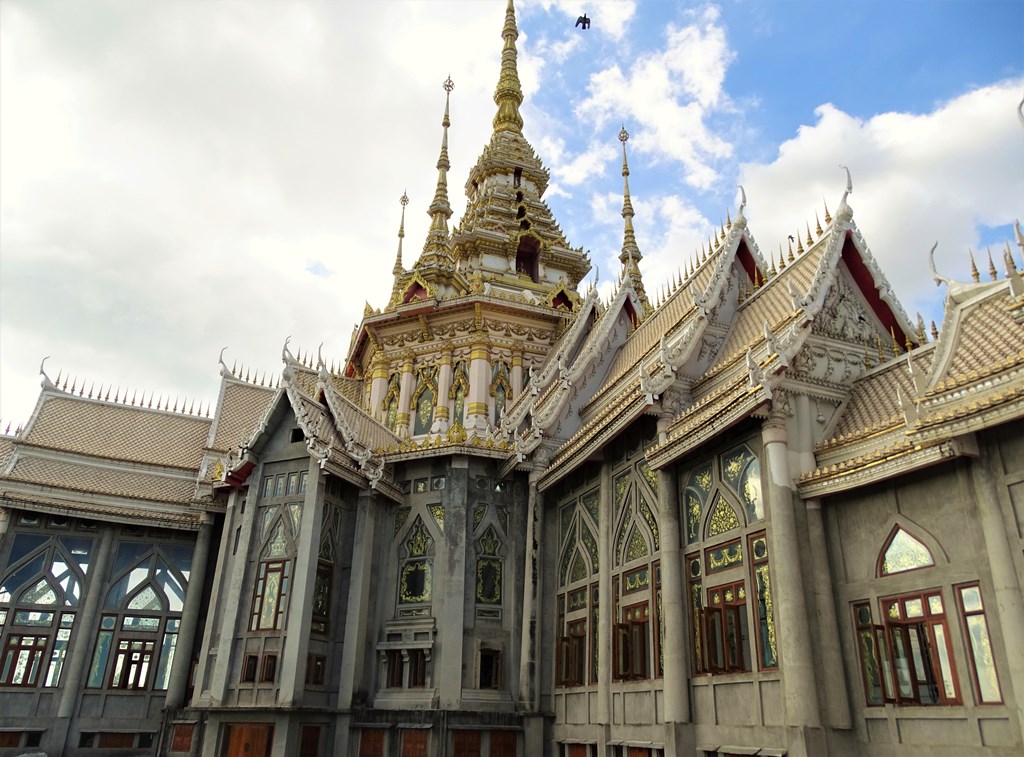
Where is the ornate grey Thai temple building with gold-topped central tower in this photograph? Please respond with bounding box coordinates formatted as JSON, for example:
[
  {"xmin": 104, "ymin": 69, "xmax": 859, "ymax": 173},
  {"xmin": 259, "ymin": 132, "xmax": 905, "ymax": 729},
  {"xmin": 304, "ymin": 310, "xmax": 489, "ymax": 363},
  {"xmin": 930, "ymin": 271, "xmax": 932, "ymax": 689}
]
[{"xmin": 0, "ymin": 0, "xmax": 1024, "ymax": 757}]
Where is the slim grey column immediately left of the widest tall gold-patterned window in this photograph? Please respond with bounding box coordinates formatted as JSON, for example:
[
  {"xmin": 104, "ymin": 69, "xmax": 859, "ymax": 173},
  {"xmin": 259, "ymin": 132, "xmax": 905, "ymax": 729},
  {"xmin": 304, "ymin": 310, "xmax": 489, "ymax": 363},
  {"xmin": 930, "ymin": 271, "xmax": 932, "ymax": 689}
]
[{"xmin": 657, "ymin": 470, "xmax": 690, "ymax": 723}]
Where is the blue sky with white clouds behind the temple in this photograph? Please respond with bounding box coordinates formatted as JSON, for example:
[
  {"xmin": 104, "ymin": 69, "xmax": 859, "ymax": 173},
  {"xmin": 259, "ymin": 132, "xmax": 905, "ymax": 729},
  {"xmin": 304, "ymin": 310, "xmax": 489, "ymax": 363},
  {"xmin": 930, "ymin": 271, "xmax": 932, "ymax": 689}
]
[{"xmin": 0, "ymin": 0, "xmax": 1024, "ymax": 432}]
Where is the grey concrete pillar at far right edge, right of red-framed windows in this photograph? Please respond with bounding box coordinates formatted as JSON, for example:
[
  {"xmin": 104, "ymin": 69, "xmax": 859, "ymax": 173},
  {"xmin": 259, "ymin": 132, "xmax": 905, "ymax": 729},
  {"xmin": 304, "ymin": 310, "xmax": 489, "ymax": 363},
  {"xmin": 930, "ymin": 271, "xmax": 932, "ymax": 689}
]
[{"xmin": 971, "ymin": 450, "xmax": 1024, "ymax": 732}]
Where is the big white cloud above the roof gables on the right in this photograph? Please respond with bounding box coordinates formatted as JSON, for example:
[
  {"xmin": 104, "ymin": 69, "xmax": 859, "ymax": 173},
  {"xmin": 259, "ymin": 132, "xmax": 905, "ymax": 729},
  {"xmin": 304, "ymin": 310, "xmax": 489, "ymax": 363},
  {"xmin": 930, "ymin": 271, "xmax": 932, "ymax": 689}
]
[{"xmin": 740, "ymin": 80, "xmax": 1024, "ymax": 318}]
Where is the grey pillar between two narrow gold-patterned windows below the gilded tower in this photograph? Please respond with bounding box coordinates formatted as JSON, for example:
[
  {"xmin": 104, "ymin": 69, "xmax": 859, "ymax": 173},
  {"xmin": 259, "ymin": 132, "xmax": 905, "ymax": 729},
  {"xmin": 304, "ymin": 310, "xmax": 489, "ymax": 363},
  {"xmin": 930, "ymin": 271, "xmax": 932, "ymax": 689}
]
[{"xmin": 433, "ymin": 455, "xmax": 468, "ymax": 710}]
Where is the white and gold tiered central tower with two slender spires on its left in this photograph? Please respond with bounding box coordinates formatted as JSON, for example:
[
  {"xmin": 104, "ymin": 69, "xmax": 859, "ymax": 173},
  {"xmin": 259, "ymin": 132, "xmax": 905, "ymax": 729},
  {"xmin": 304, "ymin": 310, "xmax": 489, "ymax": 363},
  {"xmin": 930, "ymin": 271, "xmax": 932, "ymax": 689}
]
[{"xmin": 346, "ymin": 0, "xmax": 591, "ymax": 444}]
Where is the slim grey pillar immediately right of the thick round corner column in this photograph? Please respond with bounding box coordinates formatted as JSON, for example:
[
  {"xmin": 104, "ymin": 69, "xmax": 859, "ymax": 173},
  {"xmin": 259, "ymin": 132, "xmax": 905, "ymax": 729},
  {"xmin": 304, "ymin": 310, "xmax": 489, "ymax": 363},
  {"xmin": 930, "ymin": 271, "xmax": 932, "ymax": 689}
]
[{"xmin": 802, "ymin": 499, "xmax": 853, "ymax": 729}]
